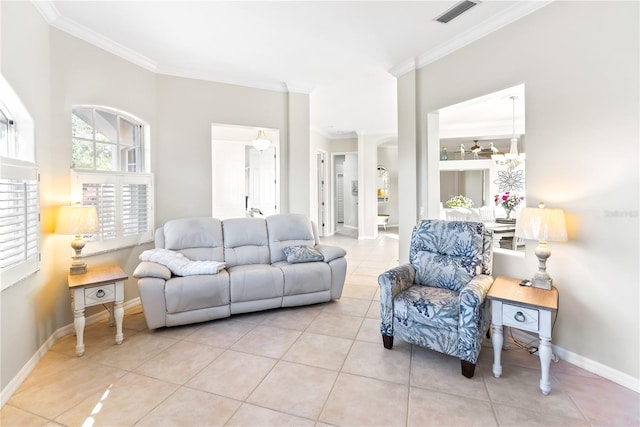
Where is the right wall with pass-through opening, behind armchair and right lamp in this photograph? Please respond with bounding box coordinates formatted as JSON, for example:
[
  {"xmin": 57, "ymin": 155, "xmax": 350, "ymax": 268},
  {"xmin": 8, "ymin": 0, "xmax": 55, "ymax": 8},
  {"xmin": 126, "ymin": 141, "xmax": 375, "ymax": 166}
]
[{"xmin": 398, "ymin": 2, "xmax": 640, "ymax": 388}]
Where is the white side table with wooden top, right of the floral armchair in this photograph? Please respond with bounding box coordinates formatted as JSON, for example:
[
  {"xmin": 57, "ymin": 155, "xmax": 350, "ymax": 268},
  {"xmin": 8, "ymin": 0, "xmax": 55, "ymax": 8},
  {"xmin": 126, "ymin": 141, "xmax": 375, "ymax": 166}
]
[{"xmin": 487, "ymin": 277, "xmax": 558, "ymax": 396}]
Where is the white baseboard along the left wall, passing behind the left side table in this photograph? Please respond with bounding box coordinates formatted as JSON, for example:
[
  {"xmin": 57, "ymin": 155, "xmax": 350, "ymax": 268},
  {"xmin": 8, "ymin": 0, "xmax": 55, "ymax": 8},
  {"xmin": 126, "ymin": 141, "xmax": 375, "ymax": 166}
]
[{"xmin": 0, "ymin": 297, "xmax": 140, "ymax": 408}]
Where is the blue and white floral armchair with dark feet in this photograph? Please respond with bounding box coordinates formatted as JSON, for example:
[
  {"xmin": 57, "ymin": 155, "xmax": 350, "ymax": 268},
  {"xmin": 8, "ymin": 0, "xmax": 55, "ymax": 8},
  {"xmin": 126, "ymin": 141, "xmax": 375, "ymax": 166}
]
[{"xmin": 378, "ymin": 220, "xmax": 493, "ymax": 378}]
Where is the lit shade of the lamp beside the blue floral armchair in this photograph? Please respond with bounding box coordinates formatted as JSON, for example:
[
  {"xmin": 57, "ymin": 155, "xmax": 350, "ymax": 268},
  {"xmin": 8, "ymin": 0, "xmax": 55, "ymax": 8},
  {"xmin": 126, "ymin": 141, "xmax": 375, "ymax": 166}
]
[{"xmin": 516, "ymin": 207, "xmax": 567, "ymax": 242}]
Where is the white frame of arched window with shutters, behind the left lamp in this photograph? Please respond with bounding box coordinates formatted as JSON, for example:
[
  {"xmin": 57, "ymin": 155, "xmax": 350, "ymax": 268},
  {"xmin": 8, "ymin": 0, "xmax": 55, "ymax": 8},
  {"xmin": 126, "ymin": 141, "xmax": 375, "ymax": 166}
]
[{"xmin": 70, "ymin": 105, "xmax": 155, "ymax": 257}]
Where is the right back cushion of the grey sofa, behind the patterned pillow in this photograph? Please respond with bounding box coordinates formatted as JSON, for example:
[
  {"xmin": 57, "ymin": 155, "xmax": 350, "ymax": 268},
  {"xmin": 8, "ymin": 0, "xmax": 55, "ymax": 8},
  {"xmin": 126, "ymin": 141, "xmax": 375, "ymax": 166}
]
[{"xmin": 266, "ymin": 214, "xmax": 316, "ymax": 263}]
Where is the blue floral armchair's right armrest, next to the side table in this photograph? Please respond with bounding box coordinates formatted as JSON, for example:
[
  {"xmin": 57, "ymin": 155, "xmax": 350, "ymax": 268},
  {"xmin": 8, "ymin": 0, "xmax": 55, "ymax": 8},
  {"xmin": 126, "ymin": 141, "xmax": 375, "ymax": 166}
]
[{"xmin": 458, "ymin": 274, "xmax": 493, "ymax": 364}]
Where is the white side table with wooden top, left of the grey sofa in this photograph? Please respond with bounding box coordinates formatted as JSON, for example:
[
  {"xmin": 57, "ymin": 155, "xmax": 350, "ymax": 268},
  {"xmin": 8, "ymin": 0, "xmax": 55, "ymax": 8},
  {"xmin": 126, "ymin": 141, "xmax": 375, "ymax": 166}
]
[{"xmin": 67, "ymin": 265, "xmax": 127, "ymax": 356}]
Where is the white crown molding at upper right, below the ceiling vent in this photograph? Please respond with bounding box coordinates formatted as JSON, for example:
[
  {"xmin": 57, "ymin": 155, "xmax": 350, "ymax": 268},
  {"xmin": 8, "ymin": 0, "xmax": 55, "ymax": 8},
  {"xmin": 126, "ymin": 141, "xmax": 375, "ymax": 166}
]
[{"xmin": 389, "ymin": 0, "xmax": 554, "ymax": 77}]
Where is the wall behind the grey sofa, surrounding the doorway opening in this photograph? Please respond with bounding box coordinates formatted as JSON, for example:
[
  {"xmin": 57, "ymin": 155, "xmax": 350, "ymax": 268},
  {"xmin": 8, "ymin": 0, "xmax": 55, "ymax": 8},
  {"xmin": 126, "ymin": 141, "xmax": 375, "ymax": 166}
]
[{"xmin": 153, "ymin": 75, "xmax": 289, "ymax": 224}]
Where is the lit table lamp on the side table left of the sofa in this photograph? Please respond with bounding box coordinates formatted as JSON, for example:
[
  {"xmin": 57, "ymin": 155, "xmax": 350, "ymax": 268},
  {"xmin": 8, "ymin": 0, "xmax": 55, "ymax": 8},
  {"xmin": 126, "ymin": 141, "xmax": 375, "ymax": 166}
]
[{"xmin": 56, "ymin": 204, "xmax": 98, "ymax": 274}]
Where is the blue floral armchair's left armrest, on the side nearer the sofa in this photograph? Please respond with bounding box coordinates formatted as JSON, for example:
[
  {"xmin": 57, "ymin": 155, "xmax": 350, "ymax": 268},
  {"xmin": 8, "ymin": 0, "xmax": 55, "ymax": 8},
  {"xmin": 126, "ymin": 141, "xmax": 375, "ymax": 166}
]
[{"xmin": 378, "ymin": 264, "xmax": 416, "ymax": 338}]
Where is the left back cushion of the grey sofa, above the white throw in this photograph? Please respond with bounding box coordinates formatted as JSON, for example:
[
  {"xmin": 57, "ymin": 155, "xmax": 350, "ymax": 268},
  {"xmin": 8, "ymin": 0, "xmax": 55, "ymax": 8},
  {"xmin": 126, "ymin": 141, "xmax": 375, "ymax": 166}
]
[{"xmin": 155, "ymin": 217, "xmax": 224, "ymax": 262}]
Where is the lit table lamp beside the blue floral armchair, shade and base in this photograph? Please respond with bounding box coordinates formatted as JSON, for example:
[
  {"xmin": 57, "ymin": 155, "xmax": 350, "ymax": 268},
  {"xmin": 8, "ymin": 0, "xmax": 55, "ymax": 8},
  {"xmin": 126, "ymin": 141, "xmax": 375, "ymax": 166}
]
[{"xmin": 515, "ymin": 203, "xmax": 567, "ymax": 290}]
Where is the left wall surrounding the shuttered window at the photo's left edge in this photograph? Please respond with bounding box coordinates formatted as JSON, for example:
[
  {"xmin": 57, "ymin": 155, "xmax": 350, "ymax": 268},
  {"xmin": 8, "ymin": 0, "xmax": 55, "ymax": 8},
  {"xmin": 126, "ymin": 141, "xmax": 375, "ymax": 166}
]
[{"xmin": 0, "ymin": 2, "xmax": 52, "ymax": 390}]
